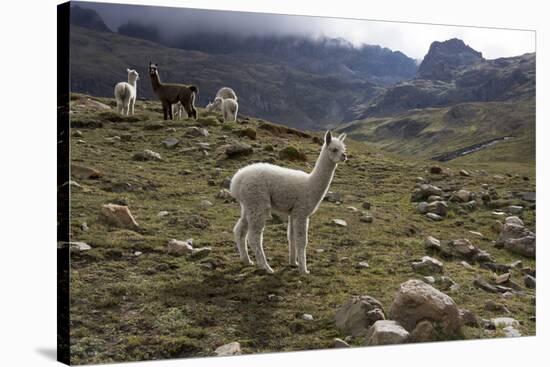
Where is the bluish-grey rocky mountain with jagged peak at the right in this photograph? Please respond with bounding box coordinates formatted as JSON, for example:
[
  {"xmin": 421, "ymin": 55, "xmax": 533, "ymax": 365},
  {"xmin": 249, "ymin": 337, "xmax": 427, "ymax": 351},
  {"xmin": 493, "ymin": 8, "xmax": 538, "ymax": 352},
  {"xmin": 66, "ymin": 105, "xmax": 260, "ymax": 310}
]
[{"xmin": 355, "ymin": 39, "xmax": 536, "ymax": 119}]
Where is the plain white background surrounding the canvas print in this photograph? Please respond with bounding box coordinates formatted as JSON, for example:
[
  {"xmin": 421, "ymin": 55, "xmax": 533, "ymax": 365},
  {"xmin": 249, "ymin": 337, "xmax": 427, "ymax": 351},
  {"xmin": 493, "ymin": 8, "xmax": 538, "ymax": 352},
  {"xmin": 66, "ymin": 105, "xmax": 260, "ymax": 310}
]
[{"xmin": 0, "ymin": 0, "xmax": 550, "ymax": 367}]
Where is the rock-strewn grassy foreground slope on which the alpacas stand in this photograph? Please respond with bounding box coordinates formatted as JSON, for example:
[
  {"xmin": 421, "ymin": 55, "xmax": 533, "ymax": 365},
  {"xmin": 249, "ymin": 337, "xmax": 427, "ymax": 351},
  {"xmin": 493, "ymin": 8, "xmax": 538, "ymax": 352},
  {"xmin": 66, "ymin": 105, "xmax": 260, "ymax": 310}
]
[{"xmin": 63, "ymin": 95, "xmax": 536, "ymax": 364}]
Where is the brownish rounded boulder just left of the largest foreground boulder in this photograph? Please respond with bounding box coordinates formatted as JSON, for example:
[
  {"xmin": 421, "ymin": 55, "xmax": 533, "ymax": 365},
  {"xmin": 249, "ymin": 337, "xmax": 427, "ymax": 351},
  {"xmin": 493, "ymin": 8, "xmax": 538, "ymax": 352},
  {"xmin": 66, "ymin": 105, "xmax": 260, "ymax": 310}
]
[{"xmin": 335, "ymin": 296, "xmax": 386, "ymax": 336}]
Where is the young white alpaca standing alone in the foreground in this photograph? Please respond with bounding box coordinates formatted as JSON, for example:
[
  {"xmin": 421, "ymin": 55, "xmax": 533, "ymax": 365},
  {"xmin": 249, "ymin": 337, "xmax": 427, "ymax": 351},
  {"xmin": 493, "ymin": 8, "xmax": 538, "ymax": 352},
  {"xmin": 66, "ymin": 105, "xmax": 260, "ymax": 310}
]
[{"xmin": 230, "ymin": 131, "xmax": 347, "ymax": 274}]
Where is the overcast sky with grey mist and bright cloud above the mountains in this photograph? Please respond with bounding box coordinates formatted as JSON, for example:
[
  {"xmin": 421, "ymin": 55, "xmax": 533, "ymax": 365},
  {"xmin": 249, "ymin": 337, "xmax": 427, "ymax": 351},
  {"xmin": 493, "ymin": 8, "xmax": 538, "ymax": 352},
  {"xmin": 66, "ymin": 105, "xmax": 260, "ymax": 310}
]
[{"xmin": 80, "ymin": 3, "xmax": 535, "ymax": 60}]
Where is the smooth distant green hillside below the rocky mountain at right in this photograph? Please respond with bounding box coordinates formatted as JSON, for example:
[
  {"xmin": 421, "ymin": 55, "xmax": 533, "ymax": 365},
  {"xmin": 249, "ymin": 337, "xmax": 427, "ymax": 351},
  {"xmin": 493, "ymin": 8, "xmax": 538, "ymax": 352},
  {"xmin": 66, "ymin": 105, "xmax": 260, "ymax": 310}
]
[{"xmin": 338, "ymin": 99, "xmax": 535, "ymax": 165}]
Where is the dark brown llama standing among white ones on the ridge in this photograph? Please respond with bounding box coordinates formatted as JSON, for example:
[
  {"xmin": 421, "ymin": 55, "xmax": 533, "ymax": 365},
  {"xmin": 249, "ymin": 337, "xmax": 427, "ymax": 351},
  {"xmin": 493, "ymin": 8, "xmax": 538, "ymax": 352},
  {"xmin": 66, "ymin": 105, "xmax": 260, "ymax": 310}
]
[{"xmin": 149, "ymin": 61, "xmax": 199, "ymax": 120}]
